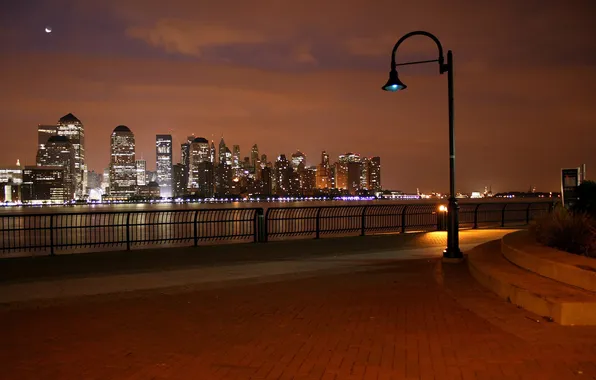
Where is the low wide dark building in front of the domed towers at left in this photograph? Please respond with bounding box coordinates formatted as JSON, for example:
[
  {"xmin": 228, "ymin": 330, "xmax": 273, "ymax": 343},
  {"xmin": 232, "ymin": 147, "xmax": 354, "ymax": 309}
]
[{"xmin": 21, "ymin": 166, "xmax": 67, "ymax": 203}]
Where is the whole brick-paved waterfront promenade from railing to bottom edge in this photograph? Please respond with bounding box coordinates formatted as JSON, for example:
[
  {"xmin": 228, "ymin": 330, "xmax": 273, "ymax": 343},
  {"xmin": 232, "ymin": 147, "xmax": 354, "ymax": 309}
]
[{"xmin": 0, "ymin": 230, "xmax": 596, "ymax": 380}]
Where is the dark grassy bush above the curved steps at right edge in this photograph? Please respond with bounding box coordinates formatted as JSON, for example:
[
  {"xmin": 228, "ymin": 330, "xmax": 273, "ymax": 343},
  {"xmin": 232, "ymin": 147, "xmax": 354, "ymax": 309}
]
[{"xmin": 533, "ymin": 205, "xmax": 596, "ymax": 257}]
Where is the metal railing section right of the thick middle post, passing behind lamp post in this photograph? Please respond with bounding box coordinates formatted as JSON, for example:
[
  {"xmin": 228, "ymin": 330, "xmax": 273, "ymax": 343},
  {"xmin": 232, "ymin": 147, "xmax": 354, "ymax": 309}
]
[{"xmin": 263, "ymin": 202, "xmax": 552, "ymax": 241}]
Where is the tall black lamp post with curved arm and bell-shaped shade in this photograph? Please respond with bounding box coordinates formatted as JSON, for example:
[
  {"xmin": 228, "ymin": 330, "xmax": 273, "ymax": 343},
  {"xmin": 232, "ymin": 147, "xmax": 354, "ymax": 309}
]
[{"xmin": 382, "ymin": 31, "xmax": 463, "ymax": 259}]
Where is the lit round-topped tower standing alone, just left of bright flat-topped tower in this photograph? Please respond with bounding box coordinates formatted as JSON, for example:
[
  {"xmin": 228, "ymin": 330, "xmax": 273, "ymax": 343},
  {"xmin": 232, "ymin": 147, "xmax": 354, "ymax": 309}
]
[{"xmin": 110, "ymin": 125, "xmax": 137, "ymax": 199}]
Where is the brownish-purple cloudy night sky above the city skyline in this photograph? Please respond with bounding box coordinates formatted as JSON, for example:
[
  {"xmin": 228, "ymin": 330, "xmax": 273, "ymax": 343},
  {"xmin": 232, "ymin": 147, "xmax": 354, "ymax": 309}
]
[{"xmin": 0, "ymin": 0, "xmax": 596, "ymax": 192}]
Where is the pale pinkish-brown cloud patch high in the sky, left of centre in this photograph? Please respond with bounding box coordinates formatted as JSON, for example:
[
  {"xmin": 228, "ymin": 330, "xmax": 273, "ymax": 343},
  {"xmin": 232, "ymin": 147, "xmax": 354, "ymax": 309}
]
[{"xmin": 126, "ymin": 19, "xmax": 266, "ymax": 56}]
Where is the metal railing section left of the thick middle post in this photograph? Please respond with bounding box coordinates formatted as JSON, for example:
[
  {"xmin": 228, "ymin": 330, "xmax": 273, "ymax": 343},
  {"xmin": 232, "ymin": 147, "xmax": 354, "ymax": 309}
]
[{"xmin": 0, "ymin": 208, "xmax": 263, "ymax": 254}]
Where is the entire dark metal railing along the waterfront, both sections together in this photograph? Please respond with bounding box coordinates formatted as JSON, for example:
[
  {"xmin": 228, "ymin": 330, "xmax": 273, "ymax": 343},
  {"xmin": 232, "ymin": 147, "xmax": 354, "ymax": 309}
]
[{"xmin": 0, "ymin": 202, "xmax": 553, "ymax": 254}]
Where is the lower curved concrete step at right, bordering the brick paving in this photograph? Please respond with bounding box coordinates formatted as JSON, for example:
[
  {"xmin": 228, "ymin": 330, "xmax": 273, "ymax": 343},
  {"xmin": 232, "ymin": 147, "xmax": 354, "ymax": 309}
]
[{"xmin": 468, "ymin": 240, "xmax": 596, "ymax": 325}]
